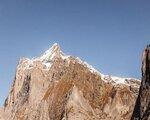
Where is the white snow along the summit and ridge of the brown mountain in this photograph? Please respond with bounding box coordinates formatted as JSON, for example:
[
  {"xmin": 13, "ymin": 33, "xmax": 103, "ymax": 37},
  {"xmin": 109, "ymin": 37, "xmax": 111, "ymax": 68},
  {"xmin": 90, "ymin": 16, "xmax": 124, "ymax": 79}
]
[{"xmin": 17, "ymin": 43, "xmax": 140, "ymax": 84}]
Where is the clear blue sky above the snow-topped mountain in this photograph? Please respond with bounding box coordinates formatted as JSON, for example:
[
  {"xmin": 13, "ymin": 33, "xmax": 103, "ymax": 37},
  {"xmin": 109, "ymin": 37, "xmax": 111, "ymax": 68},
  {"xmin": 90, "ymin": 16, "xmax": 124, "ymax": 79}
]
[{"xmin": 0, "ymin": 0, "xmax": 150, "ymax": 105}]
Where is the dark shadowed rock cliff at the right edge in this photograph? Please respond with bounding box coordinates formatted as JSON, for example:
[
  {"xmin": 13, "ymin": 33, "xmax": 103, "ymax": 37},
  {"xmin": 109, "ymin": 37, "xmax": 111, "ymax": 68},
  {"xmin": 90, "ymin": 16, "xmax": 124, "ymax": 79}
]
[{"xmin": 132, "ymin": 45, "xmax": 150, "ymax": 120}]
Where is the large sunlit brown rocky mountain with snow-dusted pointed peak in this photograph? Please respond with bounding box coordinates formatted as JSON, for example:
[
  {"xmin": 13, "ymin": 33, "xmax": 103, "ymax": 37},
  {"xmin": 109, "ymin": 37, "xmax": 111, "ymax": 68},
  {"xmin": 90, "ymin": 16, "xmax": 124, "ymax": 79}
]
[{"xmin": 0, "ymin": 44, "xmax": 140, "ymax": 120}]
